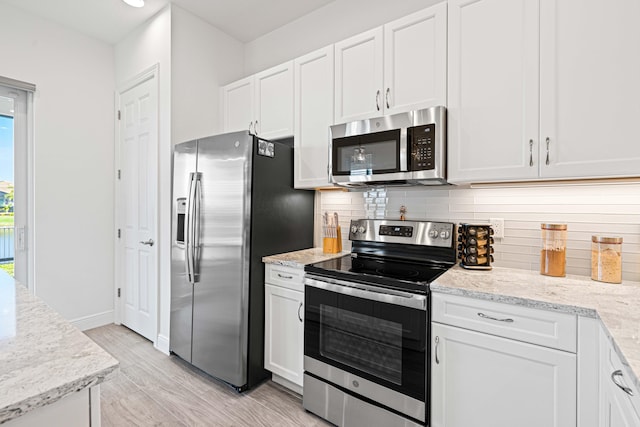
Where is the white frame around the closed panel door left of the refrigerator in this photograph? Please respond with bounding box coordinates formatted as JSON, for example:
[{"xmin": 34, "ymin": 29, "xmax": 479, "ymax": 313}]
[{"xmin": 113, "ymin": 63, "xmax": 163, "ymax": 346}]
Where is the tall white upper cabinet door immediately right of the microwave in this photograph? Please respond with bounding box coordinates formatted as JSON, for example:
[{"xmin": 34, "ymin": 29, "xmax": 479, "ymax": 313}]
[{"xmin": 447, "ymin": 0, "xmax": 540, "ymax": 182}]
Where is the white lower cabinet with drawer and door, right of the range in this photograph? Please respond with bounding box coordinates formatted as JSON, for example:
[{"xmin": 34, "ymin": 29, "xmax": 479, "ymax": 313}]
[{"xmin": 431, "ymin": 293, "xmax": 577, "ymax": 427}]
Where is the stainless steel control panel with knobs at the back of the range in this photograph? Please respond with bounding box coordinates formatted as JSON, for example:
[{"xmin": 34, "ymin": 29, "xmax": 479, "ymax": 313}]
[{"xmin": 349, "ymin": 219, "xmax": 455, "ymax": 248}]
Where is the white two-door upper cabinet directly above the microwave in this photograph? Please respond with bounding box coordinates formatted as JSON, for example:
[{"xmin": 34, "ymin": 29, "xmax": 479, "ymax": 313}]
[{"xmin": 335, "ymin": 2, "xmax": 447, "ymax": 123}]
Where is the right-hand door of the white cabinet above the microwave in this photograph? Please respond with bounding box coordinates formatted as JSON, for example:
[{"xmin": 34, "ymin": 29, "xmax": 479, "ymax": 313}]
[{"xmin": 384, "ymin": 2, "xmax": 447, "ymax": 114}]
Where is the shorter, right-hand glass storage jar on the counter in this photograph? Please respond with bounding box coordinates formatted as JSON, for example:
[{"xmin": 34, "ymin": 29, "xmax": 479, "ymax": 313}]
[{"xmin": 591, "ymin": 236, "xmax": 622, "ymax": 283}]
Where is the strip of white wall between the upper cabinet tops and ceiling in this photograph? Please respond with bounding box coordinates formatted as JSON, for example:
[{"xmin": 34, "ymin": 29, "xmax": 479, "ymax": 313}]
[{"xmin": 242, "ymin": 0, "xmax": 442, "ymax": 74}]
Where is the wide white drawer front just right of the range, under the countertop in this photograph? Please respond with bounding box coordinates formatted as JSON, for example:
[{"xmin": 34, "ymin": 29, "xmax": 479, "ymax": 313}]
[{"xmin": 431, "ymin": 293, "xmax": 578, "ymax": 353}]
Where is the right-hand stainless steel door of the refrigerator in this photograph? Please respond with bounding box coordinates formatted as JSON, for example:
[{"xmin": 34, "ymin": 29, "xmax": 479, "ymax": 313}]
[{"xmin": 192, "ymin": 132, "xmax": 253, "ymax": 387}]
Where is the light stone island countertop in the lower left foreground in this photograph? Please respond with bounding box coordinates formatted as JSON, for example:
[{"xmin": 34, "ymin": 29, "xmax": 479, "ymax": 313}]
[{"xmin": 0, "ymin": 270, "xmax": 119, "ymax": 424}]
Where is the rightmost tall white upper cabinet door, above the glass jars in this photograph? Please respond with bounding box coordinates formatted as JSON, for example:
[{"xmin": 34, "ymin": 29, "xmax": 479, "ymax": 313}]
[{"xmin": 540, "ymin": 0, "xmax": 640, "ymax": 178}]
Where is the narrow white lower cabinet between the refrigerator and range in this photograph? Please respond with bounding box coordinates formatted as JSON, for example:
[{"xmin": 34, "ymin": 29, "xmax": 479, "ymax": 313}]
[{"xmin": 264, "ymin": 264, "xmax": 304, "ymax": 394}]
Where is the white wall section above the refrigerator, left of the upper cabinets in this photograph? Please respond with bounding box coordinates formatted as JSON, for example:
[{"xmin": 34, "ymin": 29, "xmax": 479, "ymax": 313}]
[{"xmin": 171, "ymin": 5, "xmax": 244, "ymax": 144}]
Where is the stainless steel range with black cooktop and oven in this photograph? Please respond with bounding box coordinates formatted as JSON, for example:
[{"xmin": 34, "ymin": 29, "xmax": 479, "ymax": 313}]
[{"xmin": 303, "ymin": 220, "xmax": 456, "ymax": 427}]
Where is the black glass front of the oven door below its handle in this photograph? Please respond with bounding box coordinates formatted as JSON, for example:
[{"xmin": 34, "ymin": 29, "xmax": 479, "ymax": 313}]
[{"xmin": 304, "ymin": 286, "xmax": 428, "ymax": 401}]
